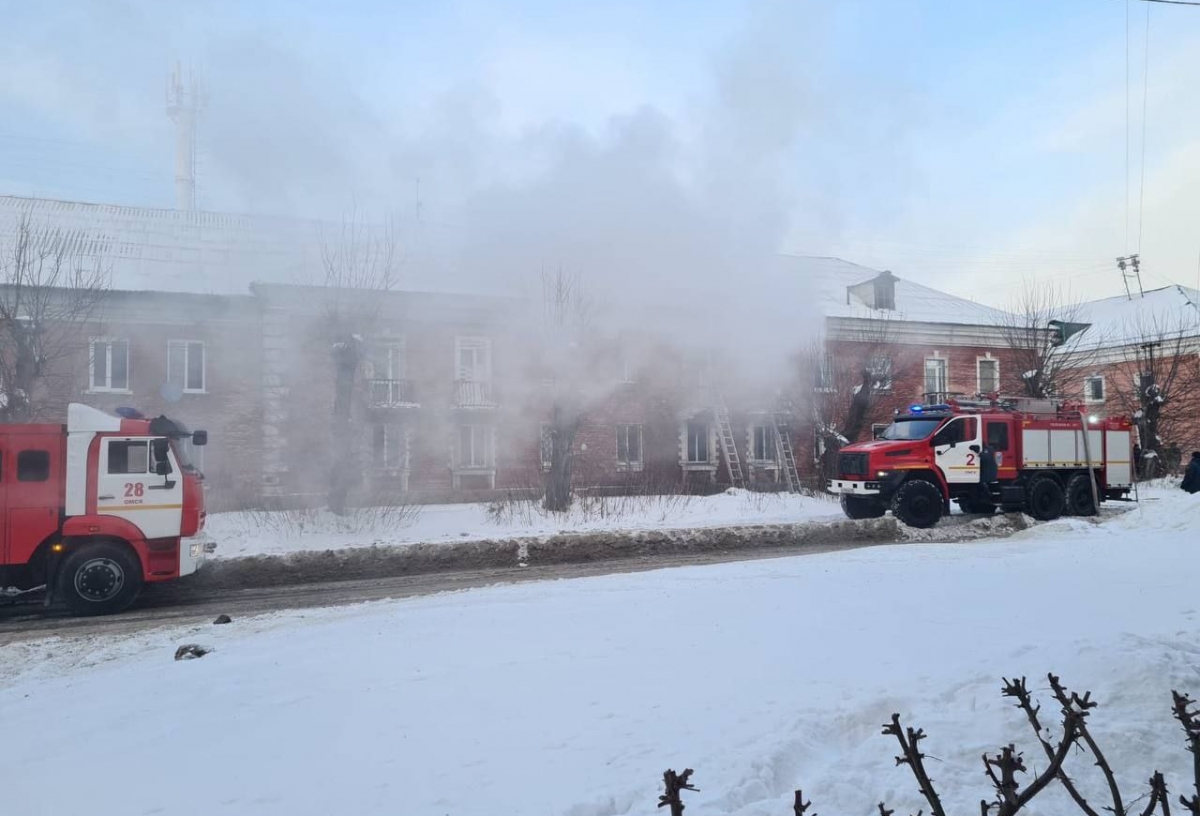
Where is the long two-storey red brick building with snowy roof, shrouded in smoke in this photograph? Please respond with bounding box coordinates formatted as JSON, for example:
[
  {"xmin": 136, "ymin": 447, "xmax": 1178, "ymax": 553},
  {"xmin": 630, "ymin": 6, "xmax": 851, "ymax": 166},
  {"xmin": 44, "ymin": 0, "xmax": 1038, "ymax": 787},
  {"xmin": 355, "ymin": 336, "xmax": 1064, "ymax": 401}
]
[{"xmin": 0, "ymin": 198, "xmax": 1032, "ymax": 506}]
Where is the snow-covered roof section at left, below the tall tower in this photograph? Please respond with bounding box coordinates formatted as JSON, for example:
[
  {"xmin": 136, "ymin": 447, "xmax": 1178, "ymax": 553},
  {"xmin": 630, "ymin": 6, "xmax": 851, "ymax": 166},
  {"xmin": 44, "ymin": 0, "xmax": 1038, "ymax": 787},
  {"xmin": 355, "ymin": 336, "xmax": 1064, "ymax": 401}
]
[{"xmin": 0, "ymin": 196, "xmax": 320, "ymax": 294}]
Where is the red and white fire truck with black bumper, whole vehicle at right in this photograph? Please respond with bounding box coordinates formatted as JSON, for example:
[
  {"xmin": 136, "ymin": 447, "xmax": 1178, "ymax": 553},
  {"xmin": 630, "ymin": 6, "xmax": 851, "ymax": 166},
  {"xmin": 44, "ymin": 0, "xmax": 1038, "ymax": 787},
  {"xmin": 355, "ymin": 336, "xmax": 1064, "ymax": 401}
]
[{"xmin": 828, "ymin": 397, "xmax": 1133, "ymax": 527}]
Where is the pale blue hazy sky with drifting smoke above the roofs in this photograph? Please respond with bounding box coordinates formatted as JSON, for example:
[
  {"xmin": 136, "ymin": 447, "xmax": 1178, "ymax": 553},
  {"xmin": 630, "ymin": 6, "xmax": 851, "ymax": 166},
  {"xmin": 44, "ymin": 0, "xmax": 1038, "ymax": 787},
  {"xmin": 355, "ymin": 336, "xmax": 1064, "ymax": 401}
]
[{"xmin": 0, "ymin": 0, "xmax": 1200, "ymax": 307}]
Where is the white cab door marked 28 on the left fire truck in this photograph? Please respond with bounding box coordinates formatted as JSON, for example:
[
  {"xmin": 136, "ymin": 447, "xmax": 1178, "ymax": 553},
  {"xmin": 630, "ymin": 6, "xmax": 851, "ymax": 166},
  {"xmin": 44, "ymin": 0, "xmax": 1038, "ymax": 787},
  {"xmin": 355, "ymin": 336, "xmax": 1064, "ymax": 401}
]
[{"xmin": 96, "ymin": 437, "xmax": 184, "ymax": 539}]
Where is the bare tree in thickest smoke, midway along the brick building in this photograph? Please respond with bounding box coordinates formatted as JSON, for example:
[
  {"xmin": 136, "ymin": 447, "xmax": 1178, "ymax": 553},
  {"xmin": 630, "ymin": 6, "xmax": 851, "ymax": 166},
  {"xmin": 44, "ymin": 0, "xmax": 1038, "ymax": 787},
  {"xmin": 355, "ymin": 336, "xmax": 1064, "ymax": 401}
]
[{"xmin": 541, "ymin": 269, "xmax": 590, "ymax": 512}]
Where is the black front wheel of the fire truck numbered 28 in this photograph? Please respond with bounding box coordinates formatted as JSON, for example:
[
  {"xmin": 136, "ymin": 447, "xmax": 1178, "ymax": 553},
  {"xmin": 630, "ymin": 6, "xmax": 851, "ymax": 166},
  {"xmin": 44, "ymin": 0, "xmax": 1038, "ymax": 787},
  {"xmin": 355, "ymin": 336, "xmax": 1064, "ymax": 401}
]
[{"xmin": 59, "ymin": 541, "xmax": 142, "ymax": 616}]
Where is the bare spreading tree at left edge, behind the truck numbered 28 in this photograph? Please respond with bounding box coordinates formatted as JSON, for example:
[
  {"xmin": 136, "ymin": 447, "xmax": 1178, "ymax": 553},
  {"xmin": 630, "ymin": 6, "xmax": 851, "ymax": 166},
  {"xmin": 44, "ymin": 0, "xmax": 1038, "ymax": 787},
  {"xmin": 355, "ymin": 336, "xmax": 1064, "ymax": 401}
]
[{"xmin": 0, "ymin": 215, "xmax": 110, "ymax": 422}]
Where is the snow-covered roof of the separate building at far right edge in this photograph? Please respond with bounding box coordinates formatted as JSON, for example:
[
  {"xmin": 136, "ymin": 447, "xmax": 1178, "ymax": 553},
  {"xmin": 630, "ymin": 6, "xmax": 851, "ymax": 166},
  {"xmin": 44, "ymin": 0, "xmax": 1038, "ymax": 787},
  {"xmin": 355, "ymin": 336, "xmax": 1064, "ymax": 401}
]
[{"xmin": 1072, "ymin": 284, "xmax": 1200, "ymax": 348}]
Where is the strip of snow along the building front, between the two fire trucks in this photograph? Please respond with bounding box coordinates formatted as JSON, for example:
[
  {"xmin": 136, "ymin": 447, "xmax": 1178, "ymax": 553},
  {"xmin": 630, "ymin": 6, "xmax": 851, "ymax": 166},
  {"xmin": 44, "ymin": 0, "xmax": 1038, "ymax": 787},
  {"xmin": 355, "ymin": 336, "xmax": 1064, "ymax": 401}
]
[{"xmin": 206, "ymin": 490, "xmax": 842, "ymax": 558}]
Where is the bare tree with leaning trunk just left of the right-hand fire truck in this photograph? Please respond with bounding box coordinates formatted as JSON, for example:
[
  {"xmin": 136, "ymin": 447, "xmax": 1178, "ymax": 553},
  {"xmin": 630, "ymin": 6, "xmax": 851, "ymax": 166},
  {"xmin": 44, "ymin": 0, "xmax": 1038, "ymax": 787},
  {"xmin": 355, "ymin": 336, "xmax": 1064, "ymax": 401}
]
[{"xmin": 794, "ymin": 320, "xmax": 904, "ymax": 479}]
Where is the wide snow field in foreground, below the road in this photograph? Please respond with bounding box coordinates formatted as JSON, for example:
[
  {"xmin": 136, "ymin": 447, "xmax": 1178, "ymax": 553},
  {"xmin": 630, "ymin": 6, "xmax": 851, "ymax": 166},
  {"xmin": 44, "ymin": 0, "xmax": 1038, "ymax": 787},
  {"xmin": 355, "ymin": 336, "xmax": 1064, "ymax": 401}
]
[{"xmin": 0, "ymin": 490, "xmax": 1200, "ymax": 816}]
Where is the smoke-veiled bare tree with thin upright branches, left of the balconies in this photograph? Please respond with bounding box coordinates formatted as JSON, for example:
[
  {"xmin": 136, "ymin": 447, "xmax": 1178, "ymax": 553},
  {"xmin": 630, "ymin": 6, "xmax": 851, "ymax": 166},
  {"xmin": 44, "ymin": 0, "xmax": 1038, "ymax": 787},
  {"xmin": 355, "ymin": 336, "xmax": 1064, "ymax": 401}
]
[{"xmin": 320, "ymin": 215, "xmax": 398, "ymax": 514}]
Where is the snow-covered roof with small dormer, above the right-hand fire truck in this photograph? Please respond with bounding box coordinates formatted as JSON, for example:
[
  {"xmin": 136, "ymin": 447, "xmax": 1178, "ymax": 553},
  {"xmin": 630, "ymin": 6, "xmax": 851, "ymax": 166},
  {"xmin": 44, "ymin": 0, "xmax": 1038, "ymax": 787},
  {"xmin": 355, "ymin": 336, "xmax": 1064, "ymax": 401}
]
[{"xmin": 779, "ymin": 254, "xmax": 1006, "ymax": 326}]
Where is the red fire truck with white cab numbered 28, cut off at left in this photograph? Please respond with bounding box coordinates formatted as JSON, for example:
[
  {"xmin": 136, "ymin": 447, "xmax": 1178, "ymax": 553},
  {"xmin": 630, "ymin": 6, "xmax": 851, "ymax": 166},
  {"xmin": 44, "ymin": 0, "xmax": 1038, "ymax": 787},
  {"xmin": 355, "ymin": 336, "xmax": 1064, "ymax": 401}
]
[{"xmin": 0, "ymin": 404, "xmax": 211, "ymax": 614}]
